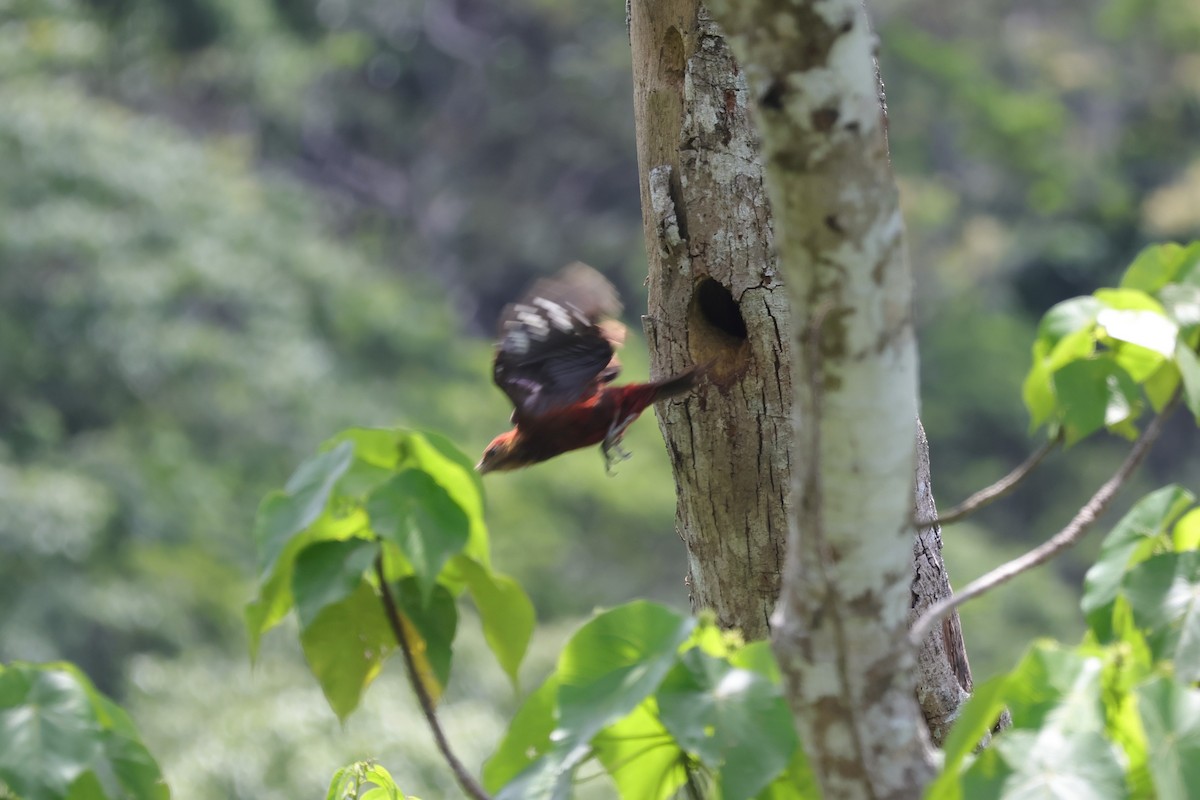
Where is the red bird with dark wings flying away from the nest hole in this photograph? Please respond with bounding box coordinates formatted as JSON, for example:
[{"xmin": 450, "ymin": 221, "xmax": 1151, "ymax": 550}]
[{"xmin": 475, "ymin": 263, "xmax": 702, "ymax": 474}]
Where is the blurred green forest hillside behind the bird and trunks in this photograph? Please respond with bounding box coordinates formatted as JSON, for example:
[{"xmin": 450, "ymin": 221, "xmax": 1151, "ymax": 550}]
[{"xmin": 0, "ymin": 0, "xmax": 1200, "ymax": 800}]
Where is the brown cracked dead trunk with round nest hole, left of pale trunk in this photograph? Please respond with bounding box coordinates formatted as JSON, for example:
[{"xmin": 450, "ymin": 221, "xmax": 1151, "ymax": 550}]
[{"xmin": 629, "ymin": 0, "xmax": 792, "ymax": 639}]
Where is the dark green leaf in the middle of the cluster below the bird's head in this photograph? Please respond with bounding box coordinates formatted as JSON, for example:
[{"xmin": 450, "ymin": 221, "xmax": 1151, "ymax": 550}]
[{"xmin": 367, "ymin": 469, "xmax": 470, "ymax": 600}]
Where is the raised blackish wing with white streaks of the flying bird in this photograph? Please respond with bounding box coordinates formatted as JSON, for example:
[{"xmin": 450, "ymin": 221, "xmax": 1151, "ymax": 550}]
[{"xmin": 492, "ymin": 264, "xmax": 624, "ymax": 420}]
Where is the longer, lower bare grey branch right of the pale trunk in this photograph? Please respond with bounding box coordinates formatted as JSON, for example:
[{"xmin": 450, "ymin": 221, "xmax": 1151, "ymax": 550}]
[{"xmin": 908, "ymin": 391, "xmax": 1181, "ymax": 646}]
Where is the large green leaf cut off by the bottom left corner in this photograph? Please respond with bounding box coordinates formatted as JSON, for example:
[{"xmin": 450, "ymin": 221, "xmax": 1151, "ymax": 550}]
[{"xmin": 0, "ymin": 663, "xmax": 169, "ymax": 800}]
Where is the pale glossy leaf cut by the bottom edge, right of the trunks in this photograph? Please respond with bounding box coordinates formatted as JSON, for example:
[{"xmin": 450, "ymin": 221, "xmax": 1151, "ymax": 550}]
[{"xmin": 962, "ymin": 728, "xmax": 1127, "ymax": 800}]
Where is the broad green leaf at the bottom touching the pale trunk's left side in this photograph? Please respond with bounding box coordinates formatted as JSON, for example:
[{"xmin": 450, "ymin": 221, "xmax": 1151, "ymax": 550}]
[{"xmin": 655, "ymin": 650, "xmax": 797, "ymax": 800}]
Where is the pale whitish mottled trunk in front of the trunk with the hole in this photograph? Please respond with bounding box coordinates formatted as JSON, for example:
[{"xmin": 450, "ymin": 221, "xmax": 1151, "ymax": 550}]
[{"xmin": 713, "ymin": 0, "xmax": 932, "ymax": 800}]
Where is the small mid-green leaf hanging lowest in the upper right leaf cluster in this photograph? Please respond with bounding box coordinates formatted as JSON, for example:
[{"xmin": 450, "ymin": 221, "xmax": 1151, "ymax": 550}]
[{"xmin": 1052, "ymin": 356, "xmax": 1139, "ymax": 445}]
